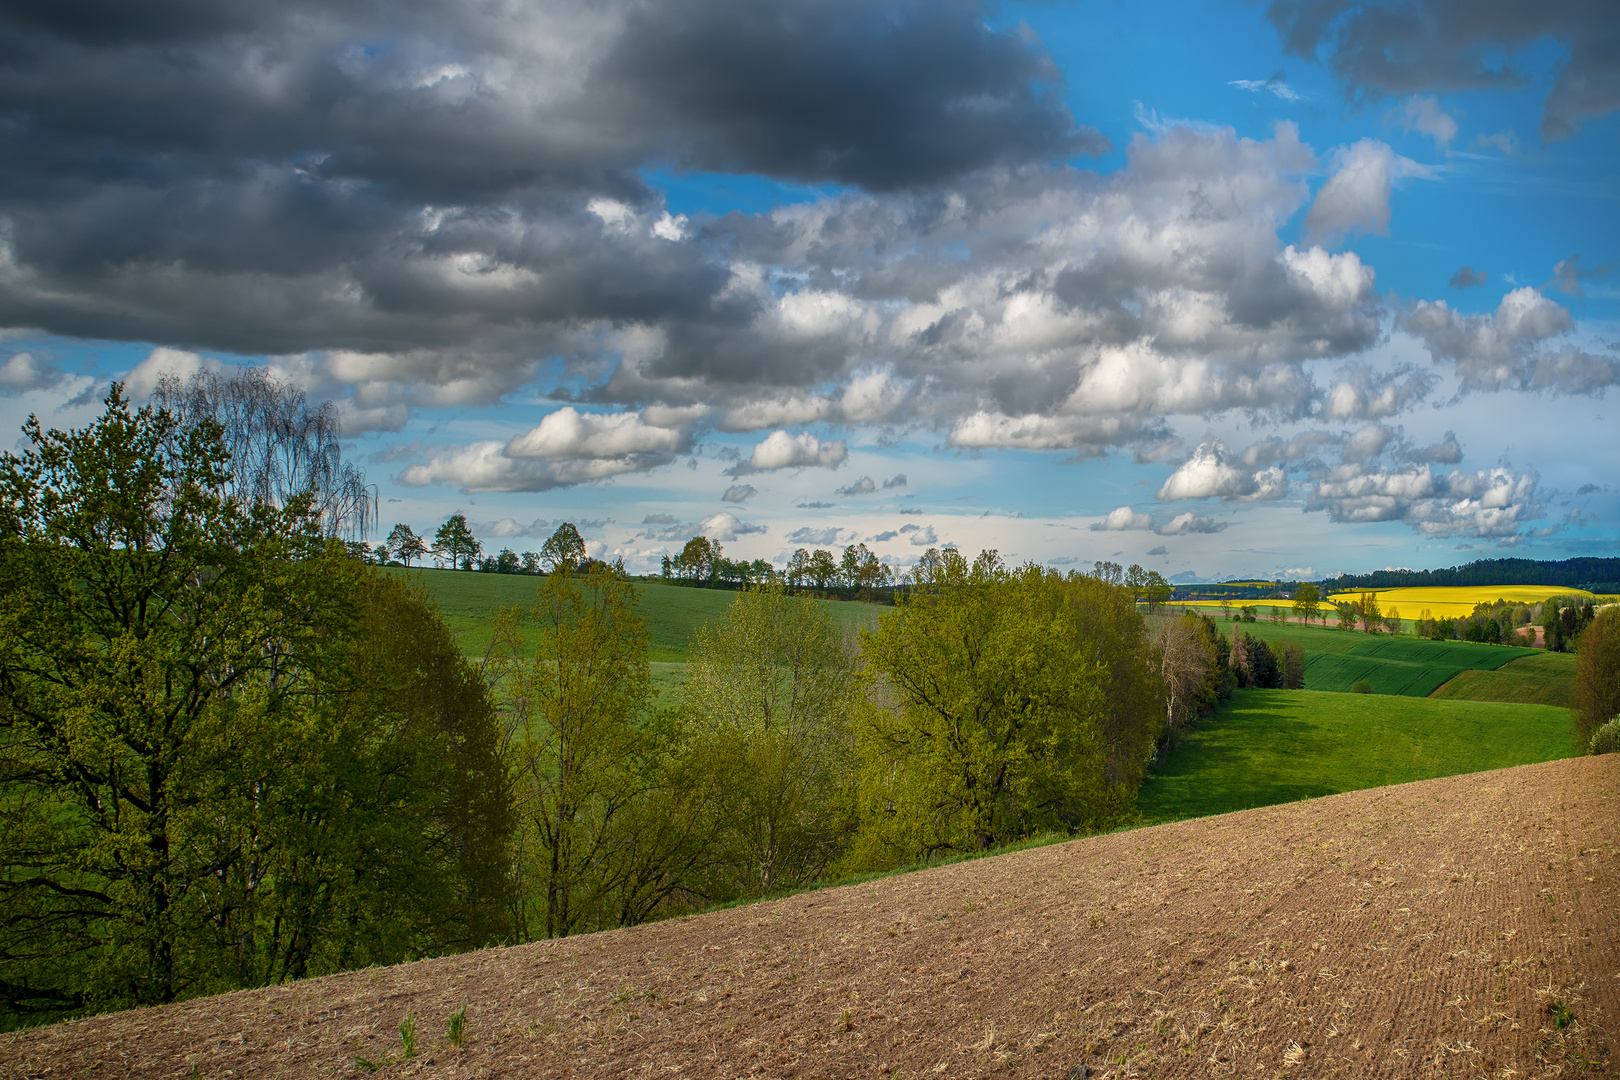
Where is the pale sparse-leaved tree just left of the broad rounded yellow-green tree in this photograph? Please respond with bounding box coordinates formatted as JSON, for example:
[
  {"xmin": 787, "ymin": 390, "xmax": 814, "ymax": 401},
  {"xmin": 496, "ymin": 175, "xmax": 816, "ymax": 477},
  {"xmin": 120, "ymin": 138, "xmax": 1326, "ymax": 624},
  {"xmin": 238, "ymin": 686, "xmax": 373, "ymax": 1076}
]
[{"xmin": 680, "ymin": 586, "xmax": 855, "ymax": 895}]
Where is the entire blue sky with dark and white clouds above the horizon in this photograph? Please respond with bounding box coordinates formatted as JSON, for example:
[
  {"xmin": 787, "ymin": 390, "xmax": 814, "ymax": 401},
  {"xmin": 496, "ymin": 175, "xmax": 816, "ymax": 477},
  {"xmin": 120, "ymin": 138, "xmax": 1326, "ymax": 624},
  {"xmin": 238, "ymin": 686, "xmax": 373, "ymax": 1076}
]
[{"xmin": 0, "ymin": 0, "xmax": 1620, "ymax": 581}]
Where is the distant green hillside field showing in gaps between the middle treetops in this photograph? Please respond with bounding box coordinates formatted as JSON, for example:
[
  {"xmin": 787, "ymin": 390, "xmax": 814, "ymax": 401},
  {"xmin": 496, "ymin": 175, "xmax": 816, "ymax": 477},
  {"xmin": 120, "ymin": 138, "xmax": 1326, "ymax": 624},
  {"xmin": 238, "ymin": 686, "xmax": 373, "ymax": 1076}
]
[{"xmin": 389, "ymin": 567, "xmax": 885, "ymax": 663}]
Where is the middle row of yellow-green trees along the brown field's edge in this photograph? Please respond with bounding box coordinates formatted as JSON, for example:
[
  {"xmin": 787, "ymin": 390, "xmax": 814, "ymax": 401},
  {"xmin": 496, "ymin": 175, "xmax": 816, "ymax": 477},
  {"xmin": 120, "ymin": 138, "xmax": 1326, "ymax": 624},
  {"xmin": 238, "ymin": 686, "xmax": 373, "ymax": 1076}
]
[{"xmin": 488, "ymin": 549, "xmax": 1179, "ymax": 936}]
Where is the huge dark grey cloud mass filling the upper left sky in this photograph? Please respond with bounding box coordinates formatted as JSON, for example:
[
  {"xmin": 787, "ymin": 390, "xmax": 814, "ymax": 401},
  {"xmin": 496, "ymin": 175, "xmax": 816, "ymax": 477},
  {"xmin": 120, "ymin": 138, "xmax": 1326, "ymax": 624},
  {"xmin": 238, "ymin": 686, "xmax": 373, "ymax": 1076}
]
[{"xmin": 0, "ymin": 0, "xmax": 1105, "ymax": 351}]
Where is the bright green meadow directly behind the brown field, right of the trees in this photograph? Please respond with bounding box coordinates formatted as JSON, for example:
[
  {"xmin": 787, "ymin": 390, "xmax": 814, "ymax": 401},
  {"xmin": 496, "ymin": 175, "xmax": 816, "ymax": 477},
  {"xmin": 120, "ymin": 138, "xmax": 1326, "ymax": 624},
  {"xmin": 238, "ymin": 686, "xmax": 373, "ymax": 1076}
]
[{"xmin": 1137, "ymin": 690, "xmax": 1581, "ymax": 824}]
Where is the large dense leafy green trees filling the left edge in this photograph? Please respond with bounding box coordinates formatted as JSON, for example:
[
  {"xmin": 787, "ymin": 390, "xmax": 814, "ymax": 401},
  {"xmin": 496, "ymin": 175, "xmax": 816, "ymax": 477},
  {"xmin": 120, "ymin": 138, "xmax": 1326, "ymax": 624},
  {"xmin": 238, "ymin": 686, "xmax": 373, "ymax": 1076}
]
[{"xmin": 0, "ymin": 387, "xmax": 504, "ymax": 1025}]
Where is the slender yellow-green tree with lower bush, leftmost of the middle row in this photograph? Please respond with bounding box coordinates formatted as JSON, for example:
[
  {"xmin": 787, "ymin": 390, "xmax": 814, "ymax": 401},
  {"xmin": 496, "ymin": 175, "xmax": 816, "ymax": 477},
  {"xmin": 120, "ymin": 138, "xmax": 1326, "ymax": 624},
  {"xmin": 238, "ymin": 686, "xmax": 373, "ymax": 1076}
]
[{"xmin": 486, "ymin": 563, "xmax": 719, "ymax": 938}]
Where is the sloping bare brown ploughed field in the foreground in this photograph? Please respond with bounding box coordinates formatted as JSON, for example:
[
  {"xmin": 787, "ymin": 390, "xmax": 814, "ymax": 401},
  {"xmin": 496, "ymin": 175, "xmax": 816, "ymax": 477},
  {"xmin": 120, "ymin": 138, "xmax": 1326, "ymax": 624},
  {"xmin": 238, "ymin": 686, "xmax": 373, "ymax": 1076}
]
[{"xmin": 0, "ymin": 755, "xmax": 1620, "ymax": 1080}]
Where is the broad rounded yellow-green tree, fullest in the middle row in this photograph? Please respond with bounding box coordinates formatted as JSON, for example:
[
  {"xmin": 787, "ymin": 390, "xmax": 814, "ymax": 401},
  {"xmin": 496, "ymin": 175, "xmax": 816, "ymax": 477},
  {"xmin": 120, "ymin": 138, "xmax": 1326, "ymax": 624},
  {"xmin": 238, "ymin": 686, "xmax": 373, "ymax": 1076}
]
[{"xmin": 854, "ymin": 549, "xmax": 1163, "ymax": 866}]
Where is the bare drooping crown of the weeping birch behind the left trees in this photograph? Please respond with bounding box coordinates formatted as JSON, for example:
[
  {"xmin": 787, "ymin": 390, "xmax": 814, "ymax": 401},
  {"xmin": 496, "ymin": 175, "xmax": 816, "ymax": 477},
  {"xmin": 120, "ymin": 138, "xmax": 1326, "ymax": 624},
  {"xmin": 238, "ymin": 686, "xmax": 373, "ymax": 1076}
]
[{"xmin": 152, "ymin": 368, "xmax": 377, "ymax": 539}]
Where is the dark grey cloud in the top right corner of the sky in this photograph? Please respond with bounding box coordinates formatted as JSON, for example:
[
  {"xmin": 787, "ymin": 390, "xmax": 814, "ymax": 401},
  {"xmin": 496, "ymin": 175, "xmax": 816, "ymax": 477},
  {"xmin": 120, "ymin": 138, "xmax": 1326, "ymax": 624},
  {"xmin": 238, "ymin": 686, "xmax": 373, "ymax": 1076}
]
[{"xmin": 1267, "ymin": 0, "xmax": 1620, "ymax": 141}]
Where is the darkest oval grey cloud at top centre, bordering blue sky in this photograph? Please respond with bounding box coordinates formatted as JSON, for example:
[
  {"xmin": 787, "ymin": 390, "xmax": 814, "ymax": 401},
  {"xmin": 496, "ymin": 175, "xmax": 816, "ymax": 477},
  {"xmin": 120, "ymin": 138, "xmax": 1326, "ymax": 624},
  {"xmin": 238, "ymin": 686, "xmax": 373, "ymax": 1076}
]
[{"xmin": 590, "ymin": 0, "xmax": 1108, "ymax": 189}]
